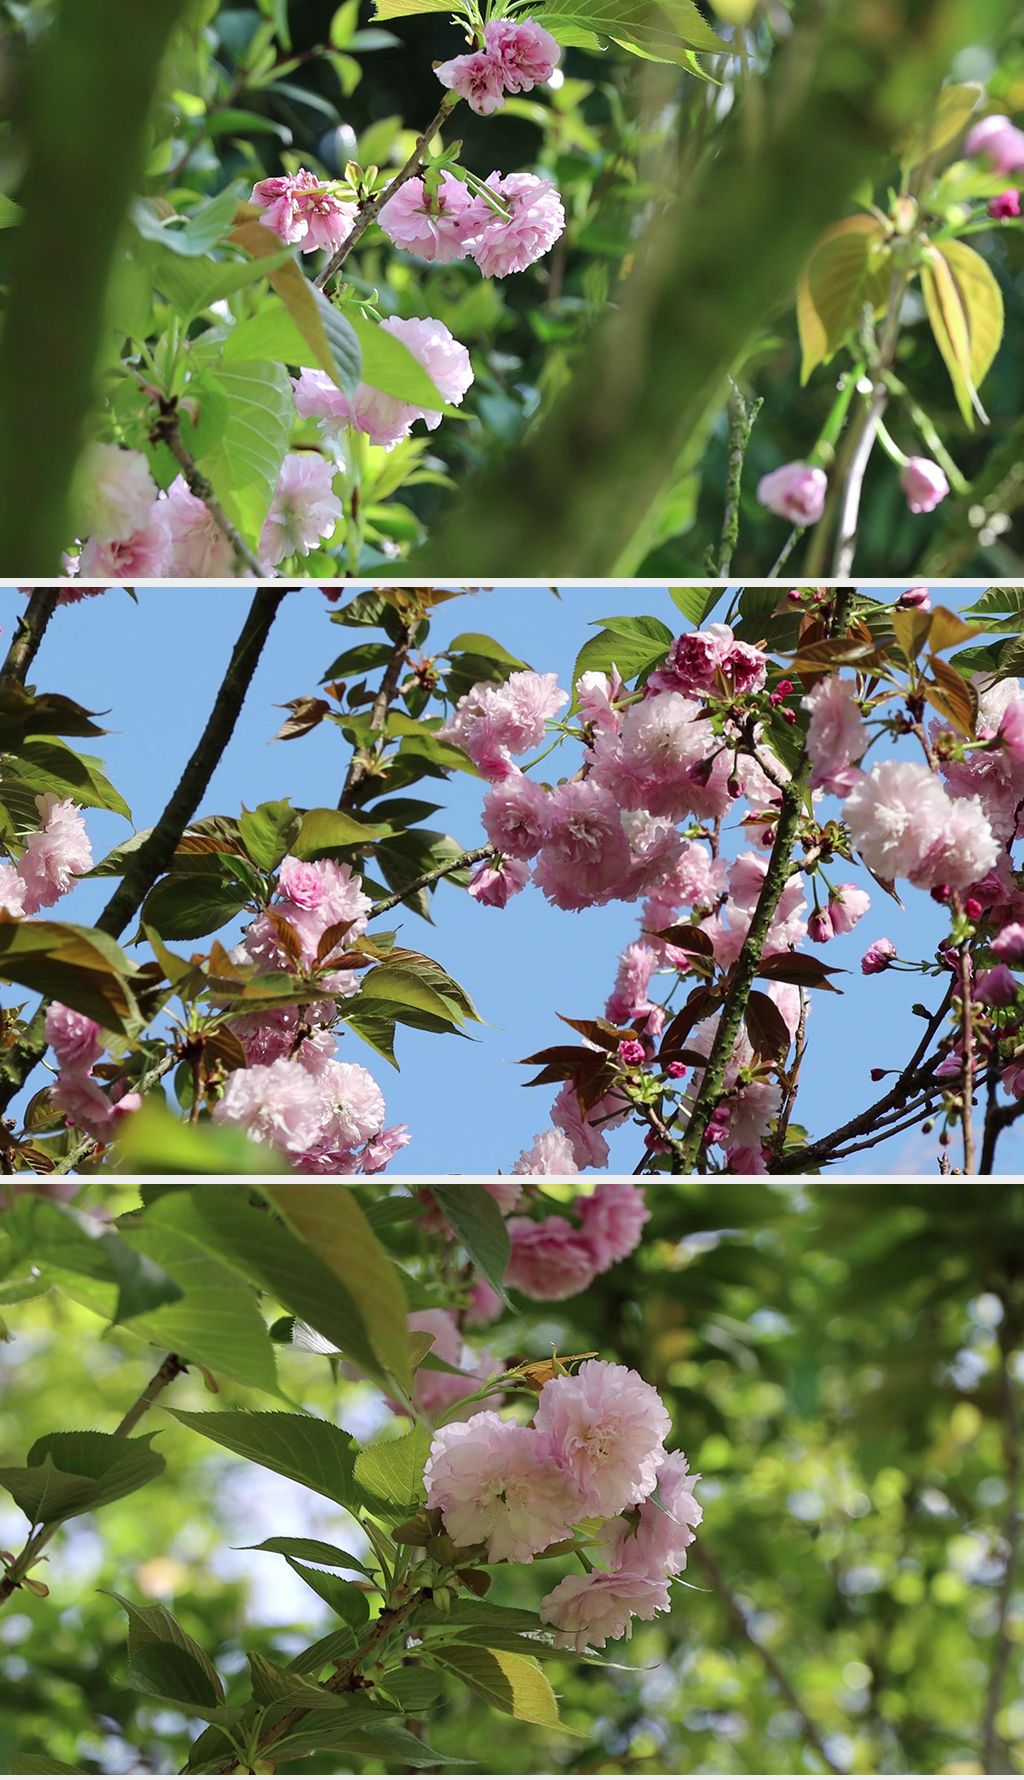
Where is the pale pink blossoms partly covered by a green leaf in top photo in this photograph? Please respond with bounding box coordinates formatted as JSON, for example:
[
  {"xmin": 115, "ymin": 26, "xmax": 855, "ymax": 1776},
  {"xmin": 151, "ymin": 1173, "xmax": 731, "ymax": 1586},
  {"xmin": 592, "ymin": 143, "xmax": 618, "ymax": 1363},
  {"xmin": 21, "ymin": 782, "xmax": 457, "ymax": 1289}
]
[{"xmin": 294, "ymin": 315, "xmax": 474, "ymax": 450}]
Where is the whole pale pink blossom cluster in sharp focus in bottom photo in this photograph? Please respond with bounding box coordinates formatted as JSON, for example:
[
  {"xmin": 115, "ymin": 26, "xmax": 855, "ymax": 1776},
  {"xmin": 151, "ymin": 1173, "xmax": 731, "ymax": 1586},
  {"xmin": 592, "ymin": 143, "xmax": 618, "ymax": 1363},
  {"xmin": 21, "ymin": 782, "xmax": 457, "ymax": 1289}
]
[{"xmin": 424, "ymin": 1360, "xmax": 702, "ymax": 1650}]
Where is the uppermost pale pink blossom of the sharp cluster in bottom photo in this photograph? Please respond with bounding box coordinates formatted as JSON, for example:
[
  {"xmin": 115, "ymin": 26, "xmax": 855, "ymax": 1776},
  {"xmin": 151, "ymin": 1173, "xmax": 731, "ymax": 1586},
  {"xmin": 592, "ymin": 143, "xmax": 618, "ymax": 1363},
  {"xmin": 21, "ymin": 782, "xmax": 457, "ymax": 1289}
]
[{"xmin": 534, "ymin": 1360, "xmax": 670, "ymax": 1515}]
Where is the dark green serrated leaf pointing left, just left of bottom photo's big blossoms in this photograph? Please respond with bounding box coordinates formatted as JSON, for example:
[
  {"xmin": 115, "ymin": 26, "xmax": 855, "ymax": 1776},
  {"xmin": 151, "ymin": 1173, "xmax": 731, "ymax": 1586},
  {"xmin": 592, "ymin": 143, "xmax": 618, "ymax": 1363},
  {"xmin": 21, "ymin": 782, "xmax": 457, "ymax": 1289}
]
[{"xmin": 169, "ymin": 1410, "xmax": 362, "ymax": 1513}]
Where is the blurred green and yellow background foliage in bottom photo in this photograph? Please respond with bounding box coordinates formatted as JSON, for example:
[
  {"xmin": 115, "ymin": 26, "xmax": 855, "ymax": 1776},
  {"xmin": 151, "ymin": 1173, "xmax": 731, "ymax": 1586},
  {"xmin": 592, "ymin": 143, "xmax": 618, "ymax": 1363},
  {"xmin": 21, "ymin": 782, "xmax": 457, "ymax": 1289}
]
[{"xmin": 0, "ymin": 1178, "xmax": 1024, "ymax": 1775}]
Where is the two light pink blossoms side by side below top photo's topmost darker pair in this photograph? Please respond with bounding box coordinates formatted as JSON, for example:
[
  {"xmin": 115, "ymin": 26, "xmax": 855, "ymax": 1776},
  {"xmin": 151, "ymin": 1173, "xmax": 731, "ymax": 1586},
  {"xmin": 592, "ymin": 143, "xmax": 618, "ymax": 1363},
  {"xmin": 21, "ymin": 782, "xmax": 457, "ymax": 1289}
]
[{"xmin": 379, "ymin": 173, "xmax": 565, "ymax": 278}]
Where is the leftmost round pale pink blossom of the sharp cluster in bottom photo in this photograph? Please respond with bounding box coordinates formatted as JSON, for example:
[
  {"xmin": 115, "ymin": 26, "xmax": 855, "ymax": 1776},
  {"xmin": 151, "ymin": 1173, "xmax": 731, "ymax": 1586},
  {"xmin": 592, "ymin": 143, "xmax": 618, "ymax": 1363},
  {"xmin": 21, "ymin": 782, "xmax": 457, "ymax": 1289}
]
[{"xmin": 424, "ymin": 1410, "xmax": 579, "ymax": 1563}]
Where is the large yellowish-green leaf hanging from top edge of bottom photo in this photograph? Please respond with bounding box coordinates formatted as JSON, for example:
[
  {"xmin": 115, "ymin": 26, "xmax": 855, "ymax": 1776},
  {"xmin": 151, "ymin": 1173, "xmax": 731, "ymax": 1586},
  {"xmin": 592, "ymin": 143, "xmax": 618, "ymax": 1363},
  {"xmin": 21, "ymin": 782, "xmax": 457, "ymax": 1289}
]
[{"xmin": 260, "ymin": 1180, "xmax": 413, "ymax": 1390}]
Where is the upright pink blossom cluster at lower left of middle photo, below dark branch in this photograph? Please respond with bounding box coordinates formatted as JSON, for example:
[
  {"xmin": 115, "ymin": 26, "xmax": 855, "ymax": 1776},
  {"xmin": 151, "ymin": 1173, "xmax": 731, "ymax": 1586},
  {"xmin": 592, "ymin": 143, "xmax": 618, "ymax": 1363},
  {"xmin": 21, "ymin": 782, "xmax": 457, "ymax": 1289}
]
[{"xmin": 214, "ymin": 856, "xmax": 410, "ymax": 1175}]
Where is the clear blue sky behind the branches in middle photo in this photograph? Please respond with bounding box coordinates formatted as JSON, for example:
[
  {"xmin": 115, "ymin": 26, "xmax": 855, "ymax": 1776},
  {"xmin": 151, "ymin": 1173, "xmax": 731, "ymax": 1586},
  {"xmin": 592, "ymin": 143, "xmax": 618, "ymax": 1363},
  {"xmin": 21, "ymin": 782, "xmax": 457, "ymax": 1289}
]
[{"xmin": 0, "ymin": 586, "xmax": 1013, "ymax": 1173}]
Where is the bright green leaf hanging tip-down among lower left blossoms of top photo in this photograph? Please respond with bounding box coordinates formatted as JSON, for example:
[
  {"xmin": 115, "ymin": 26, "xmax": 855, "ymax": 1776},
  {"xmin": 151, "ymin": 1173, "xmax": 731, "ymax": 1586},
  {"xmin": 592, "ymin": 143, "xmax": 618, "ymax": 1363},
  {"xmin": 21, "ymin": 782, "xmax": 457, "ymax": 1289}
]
[{"xmin": 192, "ymin": 363, "xmax": 296, "ymax": 543}]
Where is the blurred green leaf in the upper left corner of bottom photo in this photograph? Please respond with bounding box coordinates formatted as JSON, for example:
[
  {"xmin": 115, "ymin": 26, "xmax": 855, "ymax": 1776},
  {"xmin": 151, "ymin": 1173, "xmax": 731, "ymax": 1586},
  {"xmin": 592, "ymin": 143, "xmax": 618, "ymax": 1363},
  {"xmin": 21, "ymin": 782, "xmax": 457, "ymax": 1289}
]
[{"xmin": 2, "ymin": 1196, "xmax": 182, "ymax": 1323}]
